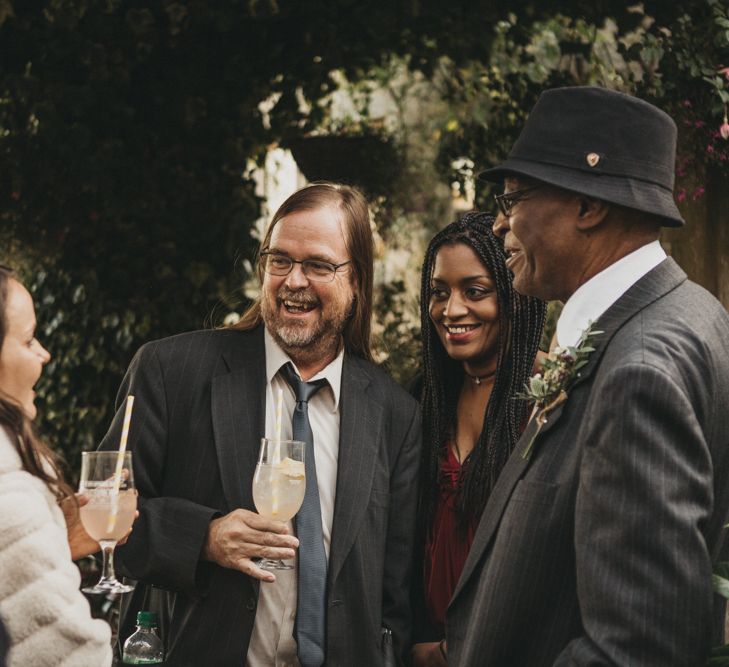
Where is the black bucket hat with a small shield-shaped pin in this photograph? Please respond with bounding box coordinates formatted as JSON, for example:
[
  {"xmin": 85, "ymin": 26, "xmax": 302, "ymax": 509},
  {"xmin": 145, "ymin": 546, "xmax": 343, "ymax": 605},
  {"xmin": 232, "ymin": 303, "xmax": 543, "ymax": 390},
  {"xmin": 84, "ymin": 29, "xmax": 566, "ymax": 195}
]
[{"xmin": 479, "ymin": 86, "xmax": 684, "ymax": 227}]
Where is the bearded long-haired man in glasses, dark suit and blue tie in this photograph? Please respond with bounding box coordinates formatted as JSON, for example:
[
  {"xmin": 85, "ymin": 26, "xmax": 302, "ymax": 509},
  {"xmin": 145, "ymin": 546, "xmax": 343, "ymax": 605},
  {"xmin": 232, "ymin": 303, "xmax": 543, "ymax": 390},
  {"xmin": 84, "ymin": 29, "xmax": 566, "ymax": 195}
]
[{"xmin": 102, "ymin": 183, "xmax": 420, "ymax": 667}]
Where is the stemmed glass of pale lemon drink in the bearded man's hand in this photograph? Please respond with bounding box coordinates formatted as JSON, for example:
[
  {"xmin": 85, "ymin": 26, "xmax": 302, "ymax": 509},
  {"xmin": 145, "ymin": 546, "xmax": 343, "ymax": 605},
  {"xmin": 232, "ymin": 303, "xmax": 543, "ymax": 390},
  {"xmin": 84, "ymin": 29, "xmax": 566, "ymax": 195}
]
[{"xmin": 253, "ymin": 438, "xmax": 306, "ymax": 570}]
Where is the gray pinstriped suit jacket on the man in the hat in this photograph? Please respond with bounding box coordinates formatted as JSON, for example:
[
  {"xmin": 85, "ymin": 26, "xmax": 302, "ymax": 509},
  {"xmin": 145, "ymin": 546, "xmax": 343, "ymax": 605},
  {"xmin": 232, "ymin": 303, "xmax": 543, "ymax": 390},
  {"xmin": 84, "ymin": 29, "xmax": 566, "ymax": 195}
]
[{"xmin": 447, "ymin": 259, "xmax": 729, "ymax": 667}]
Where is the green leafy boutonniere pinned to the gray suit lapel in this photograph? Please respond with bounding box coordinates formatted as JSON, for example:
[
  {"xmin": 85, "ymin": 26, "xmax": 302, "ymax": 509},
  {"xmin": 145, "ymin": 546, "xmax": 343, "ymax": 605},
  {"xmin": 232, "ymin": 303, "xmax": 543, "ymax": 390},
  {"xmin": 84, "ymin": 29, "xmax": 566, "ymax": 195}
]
[{"xmin": 517, "ymin": 322, "xmax": 602, "ymax": 459}]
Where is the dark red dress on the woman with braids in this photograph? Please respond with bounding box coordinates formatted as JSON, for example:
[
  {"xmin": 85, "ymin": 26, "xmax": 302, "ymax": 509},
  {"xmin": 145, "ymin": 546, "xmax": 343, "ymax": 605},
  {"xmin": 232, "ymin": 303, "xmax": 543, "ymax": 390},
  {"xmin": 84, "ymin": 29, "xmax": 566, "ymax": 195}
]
[{"xmin": 424, "ymin": 446, "xmax": 476, "ymax": 636}]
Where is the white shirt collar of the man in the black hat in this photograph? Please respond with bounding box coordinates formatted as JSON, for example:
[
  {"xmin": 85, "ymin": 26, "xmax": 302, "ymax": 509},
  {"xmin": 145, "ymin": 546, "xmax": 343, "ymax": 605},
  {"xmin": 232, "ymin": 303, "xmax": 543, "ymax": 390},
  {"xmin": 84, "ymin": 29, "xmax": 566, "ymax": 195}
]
[{"xmin": 557, "ymin": 241, "xmax": 666, "ymax": 347}]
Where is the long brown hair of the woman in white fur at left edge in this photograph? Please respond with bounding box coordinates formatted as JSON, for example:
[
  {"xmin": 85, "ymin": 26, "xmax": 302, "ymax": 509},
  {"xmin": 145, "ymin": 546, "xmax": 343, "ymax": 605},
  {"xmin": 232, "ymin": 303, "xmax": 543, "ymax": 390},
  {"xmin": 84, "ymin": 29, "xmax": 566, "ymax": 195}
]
[{"xmin": 0, "ymin": 267, "xmax": 74, "ymax": 502}]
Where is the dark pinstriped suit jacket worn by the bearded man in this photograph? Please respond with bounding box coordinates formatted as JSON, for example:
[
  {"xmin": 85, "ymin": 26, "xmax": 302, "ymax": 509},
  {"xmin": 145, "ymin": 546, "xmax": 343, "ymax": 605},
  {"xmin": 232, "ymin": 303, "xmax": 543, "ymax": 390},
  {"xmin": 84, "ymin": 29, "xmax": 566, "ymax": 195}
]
[{"xmin": 102, "ymin": 327, "xmax": 420, "ymax": 667}]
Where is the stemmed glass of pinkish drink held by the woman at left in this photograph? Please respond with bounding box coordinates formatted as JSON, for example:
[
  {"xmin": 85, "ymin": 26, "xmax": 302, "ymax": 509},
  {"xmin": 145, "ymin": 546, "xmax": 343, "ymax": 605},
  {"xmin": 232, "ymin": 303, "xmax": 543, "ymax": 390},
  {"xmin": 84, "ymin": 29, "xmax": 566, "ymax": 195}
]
[{"xmin": 79, "ymin": 451, "xmax": 137, "ymax": 594}]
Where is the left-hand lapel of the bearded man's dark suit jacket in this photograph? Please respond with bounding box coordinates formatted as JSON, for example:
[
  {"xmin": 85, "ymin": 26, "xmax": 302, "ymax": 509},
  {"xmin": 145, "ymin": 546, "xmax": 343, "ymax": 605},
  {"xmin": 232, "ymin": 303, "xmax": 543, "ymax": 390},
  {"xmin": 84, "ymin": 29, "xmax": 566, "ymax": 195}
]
[{"xmin": 211, "ymin": 327, "xmax": 266, "ymax": 510}]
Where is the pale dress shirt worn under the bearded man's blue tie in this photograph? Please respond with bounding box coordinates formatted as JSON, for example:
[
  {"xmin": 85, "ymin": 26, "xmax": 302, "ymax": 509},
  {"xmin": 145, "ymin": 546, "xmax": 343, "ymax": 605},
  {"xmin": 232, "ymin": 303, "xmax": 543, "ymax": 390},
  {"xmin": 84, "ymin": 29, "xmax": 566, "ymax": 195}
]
[{"xmin": 246, "ymin": 331, "xmax": 344, "ymax": 667}]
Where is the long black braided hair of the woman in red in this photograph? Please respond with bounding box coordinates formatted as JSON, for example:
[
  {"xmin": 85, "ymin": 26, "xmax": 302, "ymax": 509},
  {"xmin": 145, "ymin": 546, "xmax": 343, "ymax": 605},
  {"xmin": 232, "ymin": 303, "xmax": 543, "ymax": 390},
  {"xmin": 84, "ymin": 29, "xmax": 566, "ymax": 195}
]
[{"xmin": 420, "ymin": 213, "xmax": 545, "ymax": 530}]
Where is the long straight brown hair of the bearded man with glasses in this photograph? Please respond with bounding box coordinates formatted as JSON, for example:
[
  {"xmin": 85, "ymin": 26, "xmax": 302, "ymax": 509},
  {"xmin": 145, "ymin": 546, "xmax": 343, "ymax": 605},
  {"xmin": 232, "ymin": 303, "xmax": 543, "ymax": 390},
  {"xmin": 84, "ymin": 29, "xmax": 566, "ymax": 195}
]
[{"xmin": 232, "ymin": 182, "xmax": 374, "ymax": 361}]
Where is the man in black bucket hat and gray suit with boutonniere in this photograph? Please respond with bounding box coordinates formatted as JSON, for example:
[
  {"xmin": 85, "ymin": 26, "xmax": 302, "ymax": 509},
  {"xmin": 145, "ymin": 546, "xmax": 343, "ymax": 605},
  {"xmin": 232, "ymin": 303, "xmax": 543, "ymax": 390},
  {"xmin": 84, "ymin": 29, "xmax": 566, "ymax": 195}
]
[{"xmin": 446, "ymin": 87, "xmax": 729, "ymax": 667}]
